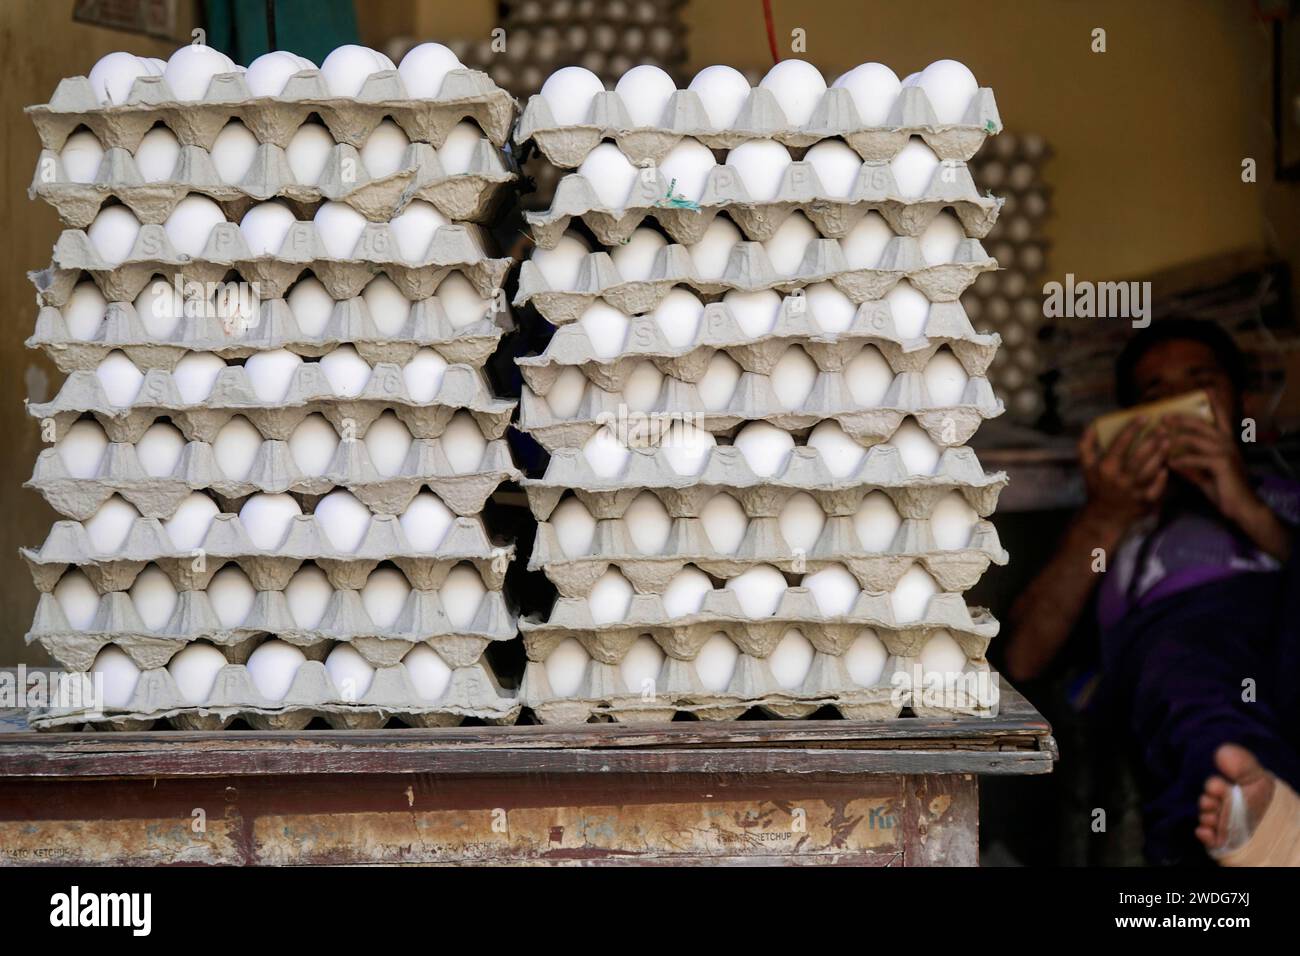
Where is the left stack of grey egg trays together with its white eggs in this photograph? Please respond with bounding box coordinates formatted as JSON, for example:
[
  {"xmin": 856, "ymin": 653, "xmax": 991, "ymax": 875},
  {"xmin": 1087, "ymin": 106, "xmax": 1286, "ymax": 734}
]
[{"xmin": 23, "ymin": 48, "xmax": 519, "ymax": 730}]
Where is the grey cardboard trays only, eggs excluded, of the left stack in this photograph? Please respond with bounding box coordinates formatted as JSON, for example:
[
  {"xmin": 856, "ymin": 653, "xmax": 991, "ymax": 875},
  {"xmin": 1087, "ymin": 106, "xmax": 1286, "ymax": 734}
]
[{"xmin": 22, "ymin": 63, "xmax": 520, "ymax": 730}]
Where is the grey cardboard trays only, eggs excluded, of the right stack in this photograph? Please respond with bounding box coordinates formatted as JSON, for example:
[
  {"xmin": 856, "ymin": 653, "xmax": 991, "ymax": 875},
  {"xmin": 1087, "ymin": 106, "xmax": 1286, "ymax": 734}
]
[{"xmin": 515, "ymin": 78, "xmax": 1006, "ymax": 723}]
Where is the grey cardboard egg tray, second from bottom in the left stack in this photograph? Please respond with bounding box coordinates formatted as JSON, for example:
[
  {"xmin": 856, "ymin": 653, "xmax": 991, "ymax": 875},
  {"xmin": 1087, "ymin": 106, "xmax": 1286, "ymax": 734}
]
[{"xmin": 27, "ymin": 589, "xmax": 519, "ymax": 672}]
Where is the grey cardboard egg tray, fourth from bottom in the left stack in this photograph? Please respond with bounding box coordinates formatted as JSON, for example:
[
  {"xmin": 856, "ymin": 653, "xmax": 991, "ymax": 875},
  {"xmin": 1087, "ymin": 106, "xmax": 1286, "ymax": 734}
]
[{"xmin": 25, "ymin": 438, "xmax": 520, "ymax": 522}]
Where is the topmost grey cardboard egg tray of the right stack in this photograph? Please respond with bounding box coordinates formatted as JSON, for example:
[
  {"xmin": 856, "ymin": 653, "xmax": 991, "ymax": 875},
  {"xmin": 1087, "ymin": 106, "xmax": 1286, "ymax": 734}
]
[{"xmin": 515, "ymin": 87, "xmax": 1002, "ymax": 168}]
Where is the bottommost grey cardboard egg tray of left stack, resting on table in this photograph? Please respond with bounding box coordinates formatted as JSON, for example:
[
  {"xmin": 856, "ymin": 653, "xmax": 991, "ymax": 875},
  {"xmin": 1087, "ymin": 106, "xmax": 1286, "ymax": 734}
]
[{"xmin": 30, "ymin": 661, "xmax": 521, "ymax": 731}]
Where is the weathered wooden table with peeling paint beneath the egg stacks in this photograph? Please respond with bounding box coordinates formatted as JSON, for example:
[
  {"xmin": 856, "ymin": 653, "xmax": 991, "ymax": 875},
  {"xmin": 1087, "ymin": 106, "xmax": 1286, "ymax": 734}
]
[{"xmin": 0, "ymin": 683, "xmax": 1056, "ymax": 866}]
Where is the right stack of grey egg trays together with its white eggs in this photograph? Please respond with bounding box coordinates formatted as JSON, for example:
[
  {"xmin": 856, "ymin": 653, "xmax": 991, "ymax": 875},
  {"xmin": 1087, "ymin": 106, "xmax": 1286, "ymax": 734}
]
[{"xmin": 515, "ymin": 67, "xmax": 1006, "ymax": 723}]
